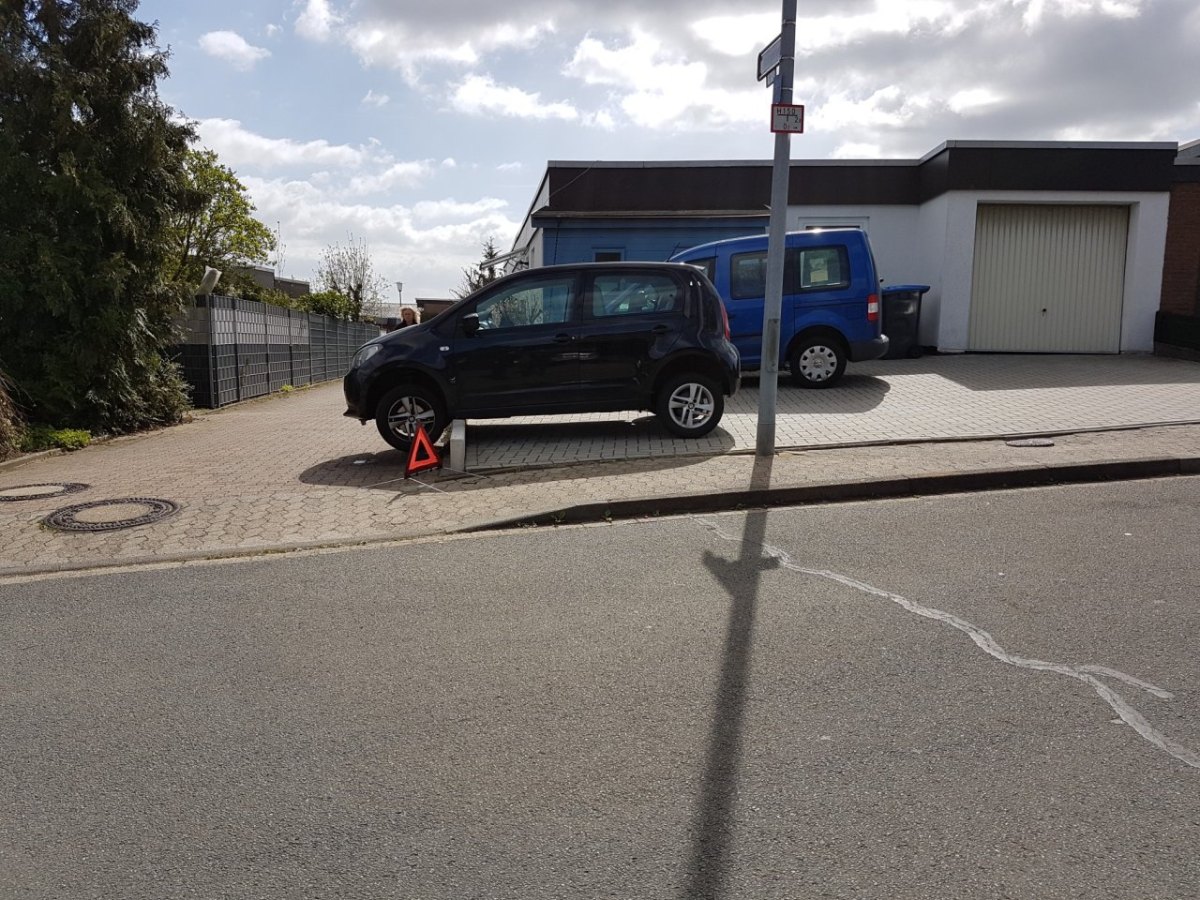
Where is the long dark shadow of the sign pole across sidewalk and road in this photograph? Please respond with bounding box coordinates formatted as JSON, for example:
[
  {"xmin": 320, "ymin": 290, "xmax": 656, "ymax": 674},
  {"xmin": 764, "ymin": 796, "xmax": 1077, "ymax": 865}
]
[{"xmin": 683, "ymin": 456, "xmax": 779, "ymax": 900}]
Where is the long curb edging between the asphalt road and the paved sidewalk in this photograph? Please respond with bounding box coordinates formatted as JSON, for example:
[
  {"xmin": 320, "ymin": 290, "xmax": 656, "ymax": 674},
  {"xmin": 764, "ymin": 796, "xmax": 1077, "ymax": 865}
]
[{"xmin": 0, "ymin": 456, "xmax": 1200, "ymax": 581}]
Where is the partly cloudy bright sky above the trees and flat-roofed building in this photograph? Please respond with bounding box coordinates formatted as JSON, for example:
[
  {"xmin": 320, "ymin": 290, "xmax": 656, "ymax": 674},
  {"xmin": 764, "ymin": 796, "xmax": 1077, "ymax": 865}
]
[{"xmin": 136, "ymin": 0, "xmax": 1200, "ymax": 304}]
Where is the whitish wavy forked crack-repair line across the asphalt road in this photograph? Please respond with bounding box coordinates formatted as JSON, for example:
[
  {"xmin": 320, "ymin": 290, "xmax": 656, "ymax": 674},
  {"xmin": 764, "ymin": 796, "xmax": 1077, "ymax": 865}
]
[{"xmin": 691, "ymin": 516, "xmax": 1200, "ymax": 769}]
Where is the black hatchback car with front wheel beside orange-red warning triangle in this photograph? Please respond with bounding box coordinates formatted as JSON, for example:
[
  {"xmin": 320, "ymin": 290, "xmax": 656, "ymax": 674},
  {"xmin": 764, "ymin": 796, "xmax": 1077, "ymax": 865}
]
[{"xmin": 343, "ymin": 263, "xmax": 739, "ymax": 450}]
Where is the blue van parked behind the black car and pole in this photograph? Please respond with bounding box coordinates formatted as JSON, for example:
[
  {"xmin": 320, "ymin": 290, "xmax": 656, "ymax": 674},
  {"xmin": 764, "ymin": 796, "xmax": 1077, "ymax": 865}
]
[{"xmin": 671, "ymin": 228, "xmax": 888, "ymax": 388}]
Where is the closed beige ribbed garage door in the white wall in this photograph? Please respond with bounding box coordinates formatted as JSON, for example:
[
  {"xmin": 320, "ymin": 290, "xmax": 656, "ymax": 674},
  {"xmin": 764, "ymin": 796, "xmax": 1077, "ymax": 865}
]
[{"xmin": 968, "ymin": 204, "xmax": 1129, "ymax": 353}]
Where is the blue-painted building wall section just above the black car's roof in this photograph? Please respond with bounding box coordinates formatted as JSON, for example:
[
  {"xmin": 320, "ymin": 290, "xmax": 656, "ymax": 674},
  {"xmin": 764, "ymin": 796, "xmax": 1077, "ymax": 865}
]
[{"xmin": 541, "ymin": 216, "xmax": 768, "ymax": 265}]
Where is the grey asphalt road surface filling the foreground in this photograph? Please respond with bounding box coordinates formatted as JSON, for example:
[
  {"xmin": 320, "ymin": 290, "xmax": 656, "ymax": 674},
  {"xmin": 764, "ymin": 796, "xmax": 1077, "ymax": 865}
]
[{"xmin": 0, "ymin": 478, "xmax": 1200, "ymax": 900}]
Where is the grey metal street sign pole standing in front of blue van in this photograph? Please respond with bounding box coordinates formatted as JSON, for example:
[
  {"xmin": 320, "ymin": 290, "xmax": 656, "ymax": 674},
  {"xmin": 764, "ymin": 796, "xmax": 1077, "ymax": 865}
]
[{"xmin": 755, "ymin": 0, "xmax": 796, "ymax": 456}]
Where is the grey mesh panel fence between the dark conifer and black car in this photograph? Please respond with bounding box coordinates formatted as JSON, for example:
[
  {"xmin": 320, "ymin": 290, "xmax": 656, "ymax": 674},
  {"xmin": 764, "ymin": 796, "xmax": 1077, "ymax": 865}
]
[{"xmin": 176, "ymin": 295, "xmax": 379, "ymax": 409}]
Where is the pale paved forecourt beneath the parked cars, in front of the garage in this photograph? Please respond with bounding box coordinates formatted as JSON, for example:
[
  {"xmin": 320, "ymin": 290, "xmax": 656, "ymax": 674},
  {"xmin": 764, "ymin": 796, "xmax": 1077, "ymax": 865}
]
[{"xmin": 467, "ymin": 355, "xmax": 1200, "ymax": 470}]
